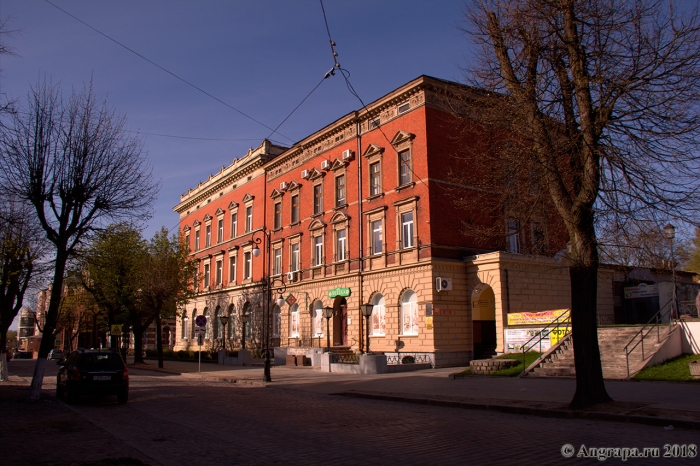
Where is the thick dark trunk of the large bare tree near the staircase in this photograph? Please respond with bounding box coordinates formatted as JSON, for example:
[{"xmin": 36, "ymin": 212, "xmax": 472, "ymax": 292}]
[{"xmin": 569, "ymin": 222, "xmax": 612, "ymax": 409}]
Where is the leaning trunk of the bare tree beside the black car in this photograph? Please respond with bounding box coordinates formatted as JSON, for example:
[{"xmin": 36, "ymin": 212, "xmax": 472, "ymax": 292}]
[{"xmin": 29, "ymin": 251, "xmax": 68, "ymax": 401}]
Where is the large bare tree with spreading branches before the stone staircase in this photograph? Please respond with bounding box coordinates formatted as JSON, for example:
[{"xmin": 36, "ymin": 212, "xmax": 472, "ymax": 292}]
[{"xmin": 466, "ymin": 0, "xmax": 700, "ymax": 408}]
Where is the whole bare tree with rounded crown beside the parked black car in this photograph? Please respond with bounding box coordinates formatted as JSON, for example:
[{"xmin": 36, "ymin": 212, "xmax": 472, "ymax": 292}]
[{"xmin": 0, "ymin": 81, "xmax": 158, "ymax": 400}]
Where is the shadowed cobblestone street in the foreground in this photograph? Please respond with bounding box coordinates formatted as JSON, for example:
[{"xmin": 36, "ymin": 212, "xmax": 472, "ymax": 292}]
[{"xmin": 0, "ymin": 360, "xmax": 700, "ymax": 465}]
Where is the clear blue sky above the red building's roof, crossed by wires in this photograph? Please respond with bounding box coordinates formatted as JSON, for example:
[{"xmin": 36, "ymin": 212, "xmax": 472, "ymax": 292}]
[{"xmin": 0, "ymin": 0, "xmax": 470, "ymax": 328}]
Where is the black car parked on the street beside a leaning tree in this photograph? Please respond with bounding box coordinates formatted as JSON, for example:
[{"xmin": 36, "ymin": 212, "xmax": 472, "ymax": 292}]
[{"xmin": 56, "ymin": 349, "xmax": 129, "ymax": 403}]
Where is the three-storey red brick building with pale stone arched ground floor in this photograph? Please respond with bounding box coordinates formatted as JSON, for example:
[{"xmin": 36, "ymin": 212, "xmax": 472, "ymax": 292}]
[{"xmin": 175, "ymin": 76, "xmax": 569, "ymax": 366}]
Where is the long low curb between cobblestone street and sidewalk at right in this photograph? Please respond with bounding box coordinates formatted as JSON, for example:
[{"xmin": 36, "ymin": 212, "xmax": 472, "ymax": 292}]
[{"xmin": 333, "ymin": 391, "xmax": 700, "ymax": 430}]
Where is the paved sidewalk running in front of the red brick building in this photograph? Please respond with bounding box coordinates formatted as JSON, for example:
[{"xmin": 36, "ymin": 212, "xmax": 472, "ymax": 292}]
[{"xmin": 130, "ymin": 360, "xmax": 700, "ymax": 429}]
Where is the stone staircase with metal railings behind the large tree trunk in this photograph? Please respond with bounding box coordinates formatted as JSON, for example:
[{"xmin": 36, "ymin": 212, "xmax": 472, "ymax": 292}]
[{"xmin": 525, "ymin": 326, "xmax": 669, "ymax": 379}]
